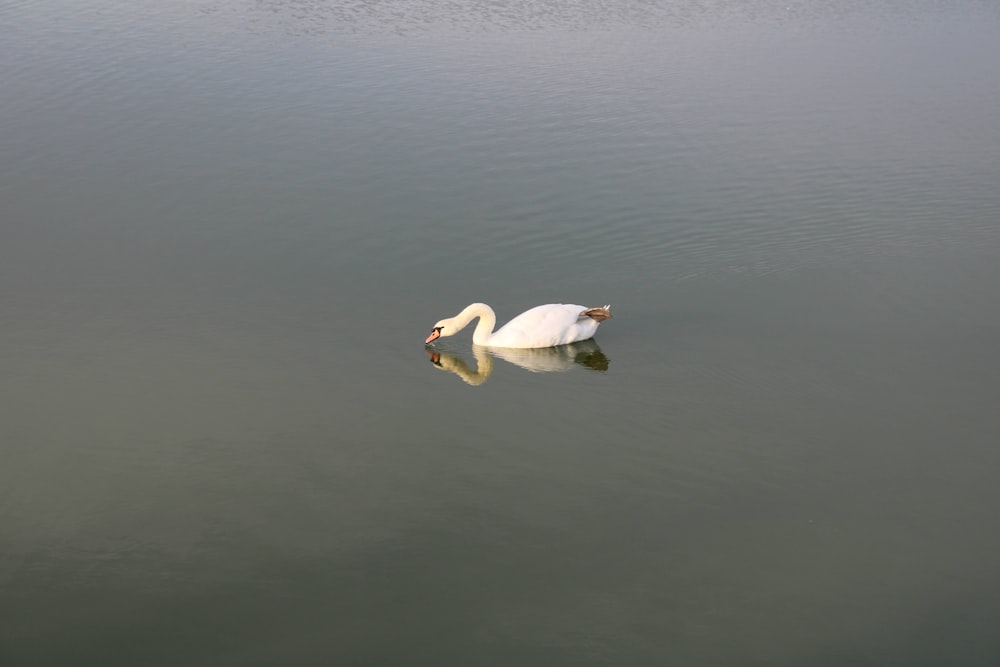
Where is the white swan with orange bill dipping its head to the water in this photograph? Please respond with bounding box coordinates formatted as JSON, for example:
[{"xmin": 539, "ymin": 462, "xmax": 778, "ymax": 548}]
[{"xmin": 424, "ymin": 303, "xmax": 611, "ymax": 348}]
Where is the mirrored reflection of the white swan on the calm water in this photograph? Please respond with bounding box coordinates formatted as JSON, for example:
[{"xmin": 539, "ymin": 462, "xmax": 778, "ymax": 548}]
[{"xmin": 425, "ymin": 339, "xmax": 611, "ymax": 386}]
